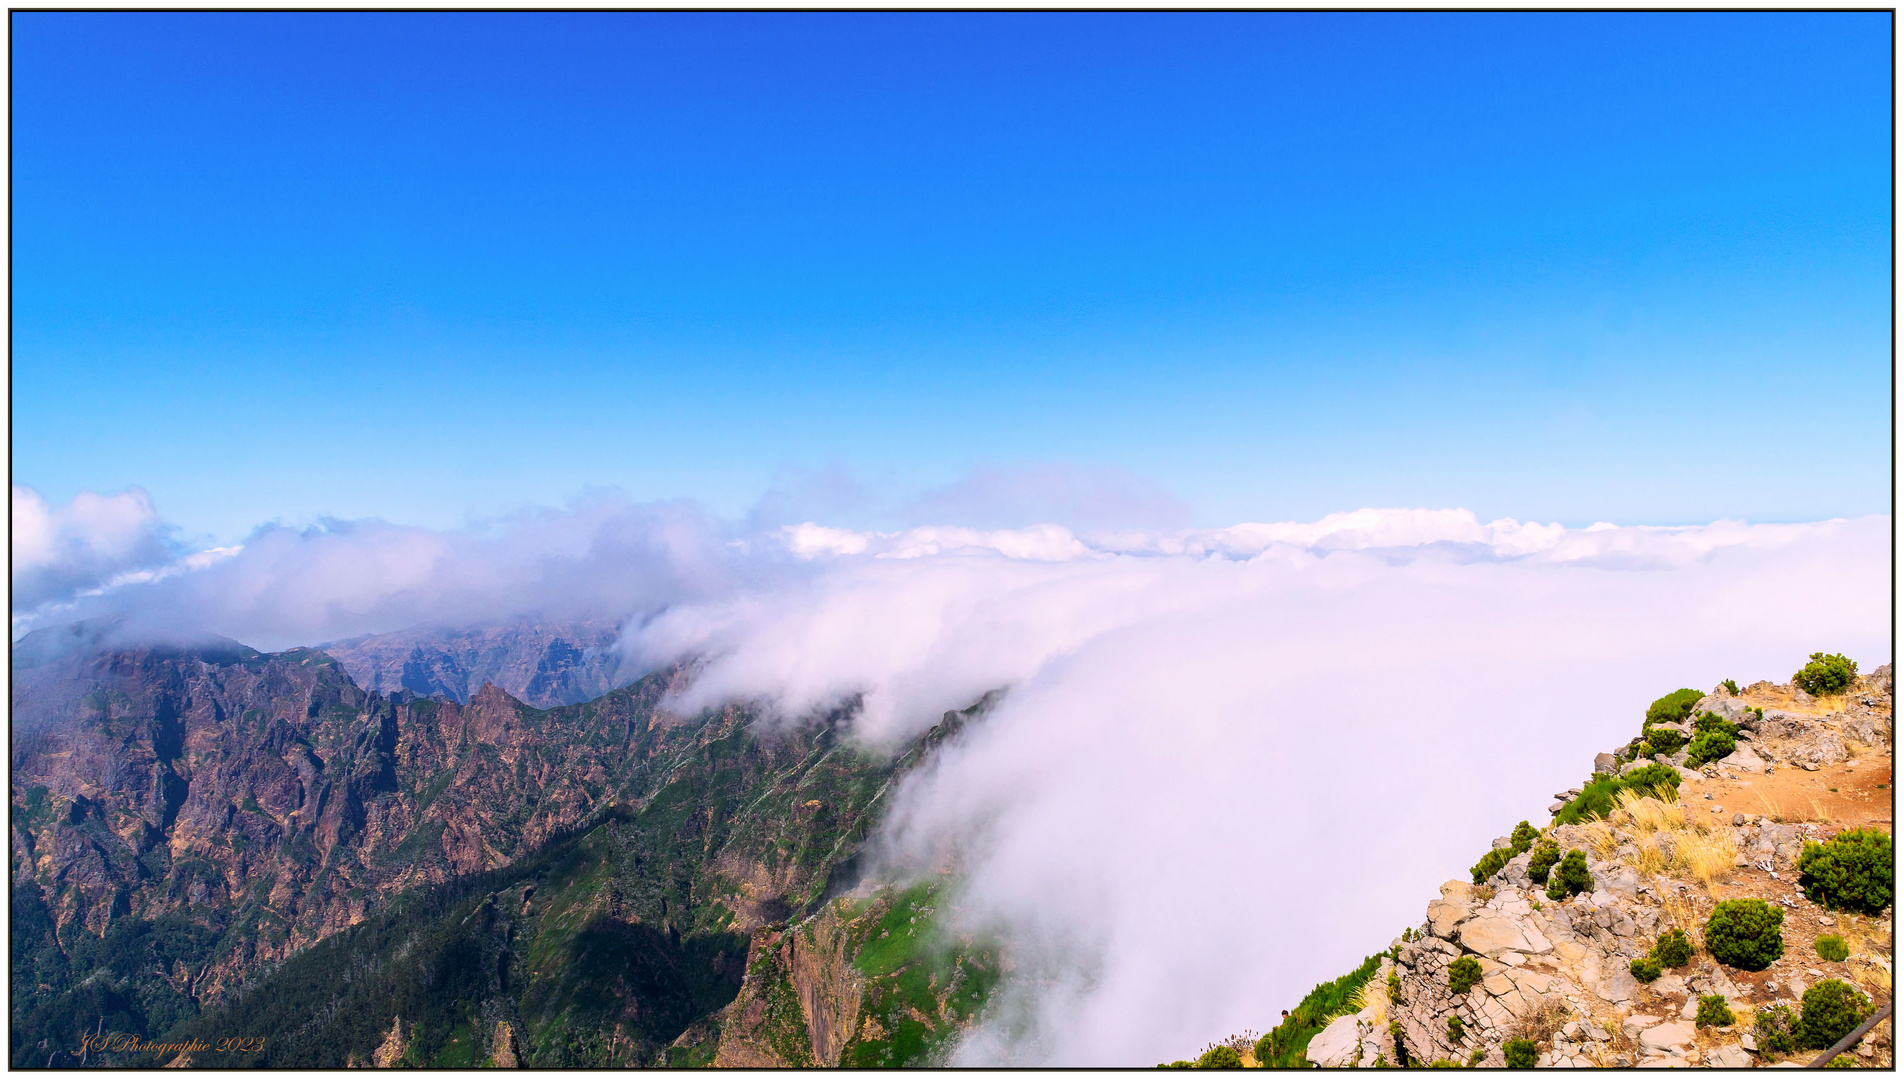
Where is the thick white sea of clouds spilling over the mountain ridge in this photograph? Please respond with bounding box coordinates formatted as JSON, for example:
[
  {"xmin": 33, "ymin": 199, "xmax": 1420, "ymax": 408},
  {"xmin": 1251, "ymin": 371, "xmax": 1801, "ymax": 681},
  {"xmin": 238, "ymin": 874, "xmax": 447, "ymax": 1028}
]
[{"xmin": 13, "ymin": 488, "xmax": 1893, "ymax": 1065}]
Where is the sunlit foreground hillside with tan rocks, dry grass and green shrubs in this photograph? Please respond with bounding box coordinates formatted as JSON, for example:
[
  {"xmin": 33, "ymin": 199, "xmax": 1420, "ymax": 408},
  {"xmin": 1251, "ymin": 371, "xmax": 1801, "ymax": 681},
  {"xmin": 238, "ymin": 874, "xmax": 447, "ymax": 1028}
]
[{"xmin": 1217, "ymin": 665, "xmax": 1894, "ymax": 1069}]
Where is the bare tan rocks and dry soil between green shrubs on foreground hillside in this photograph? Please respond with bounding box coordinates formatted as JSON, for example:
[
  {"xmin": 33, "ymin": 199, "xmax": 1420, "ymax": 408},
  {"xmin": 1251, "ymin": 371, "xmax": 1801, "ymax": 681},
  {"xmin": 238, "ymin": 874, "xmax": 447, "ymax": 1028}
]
[{"xmin": 1308, "ymin": 665, "xmax": 1893, "ymax": 1069}]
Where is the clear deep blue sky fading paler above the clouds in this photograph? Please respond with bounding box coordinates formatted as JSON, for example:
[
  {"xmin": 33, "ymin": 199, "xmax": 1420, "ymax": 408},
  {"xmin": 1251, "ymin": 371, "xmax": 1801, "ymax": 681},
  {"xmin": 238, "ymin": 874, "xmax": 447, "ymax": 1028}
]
[{"xmin": 11, "ymin": 13, "xmax": 1891, "ymax": 539}]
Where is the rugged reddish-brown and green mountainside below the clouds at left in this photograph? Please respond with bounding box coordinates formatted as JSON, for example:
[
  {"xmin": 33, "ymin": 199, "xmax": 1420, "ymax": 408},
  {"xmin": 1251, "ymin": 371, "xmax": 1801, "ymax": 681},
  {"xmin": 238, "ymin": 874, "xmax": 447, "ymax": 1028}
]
[{"xmin": 10, "ymin": 628, "xmax": 990, "ymax": 1067}]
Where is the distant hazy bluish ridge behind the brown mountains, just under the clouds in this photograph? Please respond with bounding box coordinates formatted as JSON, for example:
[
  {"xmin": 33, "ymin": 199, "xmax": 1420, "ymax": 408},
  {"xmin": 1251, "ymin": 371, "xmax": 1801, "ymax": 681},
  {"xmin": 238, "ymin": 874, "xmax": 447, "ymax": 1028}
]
[{"xmin": 318, "ymin": 619, "xmax": 632, "ymax": 709}]
